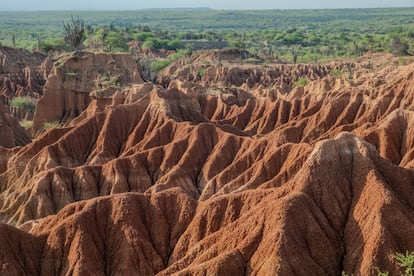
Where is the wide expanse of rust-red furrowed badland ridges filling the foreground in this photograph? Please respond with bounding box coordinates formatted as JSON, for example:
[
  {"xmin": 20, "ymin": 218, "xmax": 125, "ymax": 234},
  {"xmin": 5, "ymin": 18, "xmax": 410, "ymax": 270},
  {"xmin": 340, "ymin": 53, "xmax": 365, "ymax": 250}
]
[{"xmin": 0, "ymin": 50, "xmax": 414, "ymax": 275}]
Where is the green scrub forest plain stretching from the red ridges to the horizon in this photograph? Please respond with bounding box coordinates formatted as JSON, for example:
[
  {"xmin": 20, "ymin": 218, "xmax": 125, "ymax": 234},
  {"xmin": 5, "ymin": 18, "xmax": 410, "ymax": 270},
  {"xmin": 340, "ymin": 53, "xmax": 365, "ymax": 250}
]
[{"xmin": 0, "ymin": 8, "xmax": 414, "ymax": 66}]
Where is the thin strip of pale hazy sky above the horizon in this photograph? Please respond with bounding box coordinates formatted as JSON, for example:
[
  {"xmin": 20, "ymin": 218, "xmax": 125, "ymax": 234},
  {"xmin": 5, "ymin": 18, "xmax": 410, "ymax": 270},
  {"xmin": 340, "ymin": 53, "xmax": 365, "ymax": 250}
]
[{"xmin": 0, "ymin": 0, "xmax": 414, "ymax": 10}]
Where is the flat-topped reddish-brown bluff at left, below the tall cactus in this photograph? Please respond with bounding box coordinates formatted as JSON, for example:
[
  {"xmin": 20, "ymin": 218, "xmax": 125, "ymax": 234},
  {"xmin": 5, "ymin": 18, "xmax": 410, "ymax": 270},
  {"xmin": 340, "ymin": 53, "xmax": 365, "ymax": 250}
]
[{"xmin": 33, "ymin": 52, "xmax": 142, "ymax": 132}]
